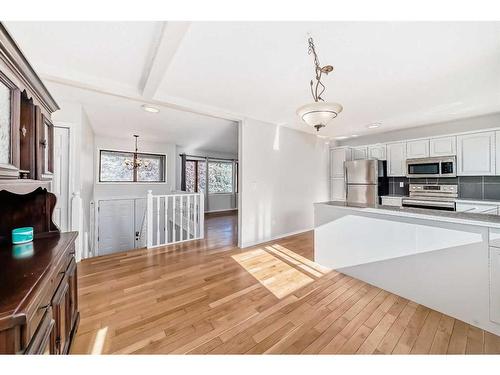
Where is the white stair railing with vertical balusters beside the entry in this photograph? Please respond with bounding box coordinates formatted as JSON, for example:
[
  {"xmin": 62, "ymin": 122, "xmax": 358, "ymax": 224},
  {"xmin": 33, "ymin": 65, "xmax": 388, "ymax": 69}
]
[{"xmin": 146, "ymin": 190, "xmax": 205, "ymax": 249}]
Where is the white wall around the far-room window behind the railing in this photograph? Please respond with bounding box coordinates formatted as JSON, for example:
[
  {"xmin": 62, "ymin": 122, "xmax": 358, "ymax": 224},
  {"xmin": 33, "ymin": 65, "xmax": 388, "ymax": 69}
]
[{"xmin": 175, "ymin": 147, "xmax": 238, "ymax": 212}]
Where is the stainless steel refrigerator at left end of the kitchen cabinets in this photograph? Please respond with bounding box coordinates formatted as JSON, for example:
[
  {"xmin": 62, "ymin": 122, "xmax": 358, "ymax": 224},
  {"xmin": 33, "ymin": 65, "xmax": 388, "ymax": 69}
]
[{"xmin": 345, "ymin": 159, "xmax": 389, "ymax": 205}]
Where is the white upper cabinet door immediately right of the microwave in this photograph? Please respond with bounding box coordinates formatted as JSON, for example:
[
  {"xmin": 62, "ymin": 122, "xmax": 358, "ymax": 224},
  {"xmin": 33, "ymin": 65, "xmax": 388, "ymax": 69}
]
[{"xmin": 457, "ymin": 132, "xmax": 495, "ymax": 176}]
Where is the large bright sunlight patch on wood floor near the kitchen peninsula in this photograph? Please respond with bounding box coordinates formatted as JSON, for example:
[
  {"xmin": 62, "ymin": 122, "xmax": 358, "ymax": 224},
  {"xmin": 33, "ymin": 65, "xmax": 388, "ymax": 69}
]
[{"xmin": 232, "ymin": 245, "xmax": 329, "ymax": 298}]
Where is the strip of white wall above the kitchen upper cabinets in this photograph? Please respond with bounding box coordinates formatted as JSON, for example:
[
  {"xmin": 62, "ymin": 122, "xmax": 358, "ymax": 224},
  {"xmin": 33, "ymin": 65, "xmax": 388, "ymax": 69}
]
[{"xmin": 337, "ymin": 113, "xmax": 500, "ymax": 146}]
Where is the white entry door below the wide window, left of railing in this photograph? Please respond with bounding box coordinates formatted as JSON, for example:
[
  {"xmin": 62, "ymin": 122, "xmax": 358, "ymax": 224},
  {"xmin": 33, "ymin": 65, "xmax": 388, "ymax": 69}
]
[{"xmin": 97, "ymin": 199, "xmax": 135, "ymax": 255}]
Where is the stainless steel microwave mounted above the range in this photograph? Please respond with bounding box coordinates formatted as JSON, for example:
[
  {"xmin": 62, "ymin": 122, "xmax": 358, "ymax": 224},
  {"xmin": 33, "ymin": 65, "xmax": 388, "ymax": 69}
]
[{"xmin": 406, "ymin": 156, "xmax": 457, "ymax": 178}]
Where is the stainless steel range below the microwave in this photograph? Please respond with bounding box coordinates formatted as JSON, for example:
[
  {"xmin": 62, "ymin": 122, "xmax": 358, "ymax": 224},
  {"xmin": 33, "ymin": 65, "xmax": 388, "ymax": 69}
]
[{"xmin": 403, "ymin": 184, "xmax": 458, "ymax": 211}]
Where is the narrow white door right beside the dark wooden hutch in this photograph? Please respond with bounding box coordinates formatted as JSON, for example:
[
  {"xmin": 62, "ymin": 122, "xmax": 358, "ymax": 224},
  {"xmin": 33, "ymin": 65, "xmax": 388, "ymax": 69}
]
[{"xmin": 52, "ymin": 126, "xmax": 69, "ymax": 232}]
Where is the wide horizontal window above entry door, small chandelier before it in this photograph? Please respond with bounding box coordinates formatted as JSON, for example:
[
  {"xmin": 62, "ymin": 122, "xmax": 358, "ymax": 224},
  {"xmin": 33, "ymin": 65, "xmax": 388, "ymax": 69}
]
[{"xmin": 99, "ymin": 150, "xmax": 165, "ymax": 182}]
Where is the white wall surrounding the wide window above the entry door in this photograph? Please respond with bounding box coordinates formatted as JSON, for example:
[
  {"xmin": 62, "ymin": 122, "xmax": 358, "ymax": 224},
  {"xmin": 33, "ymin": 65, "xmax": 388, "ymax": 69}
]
[{"xmin": 94, "ymin": 136, "xmax": 176, "ymax": 200}]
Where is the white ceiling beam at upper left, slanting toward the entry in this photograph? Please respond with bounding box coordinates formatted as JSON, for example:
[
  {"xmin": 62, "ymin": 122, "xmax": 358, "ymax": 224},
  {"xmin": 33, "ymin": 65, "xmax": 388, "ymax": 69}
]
[{"xmin": 140, "ymin": 22, "xmax": 190, "ymax": 99}]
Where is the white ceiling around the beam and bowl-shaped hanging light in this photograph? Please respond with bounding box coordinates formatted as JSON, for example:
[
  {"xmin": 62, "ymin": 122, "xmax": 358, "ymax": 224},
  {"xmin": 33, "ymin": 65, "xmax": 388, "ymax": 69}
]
[{"xmin": 3, "ymin": 22, "xmax": 500, "ymax": 142}]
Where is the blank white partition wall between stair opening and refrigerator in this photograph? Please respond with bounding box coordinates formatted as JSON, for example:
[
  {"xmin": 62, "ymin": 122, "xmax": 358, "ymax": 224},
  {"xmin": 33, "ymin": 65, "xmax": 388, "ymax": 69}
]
[{"xmin": 240, "ymin": 119, "xmax": 329, "ymax": 247}]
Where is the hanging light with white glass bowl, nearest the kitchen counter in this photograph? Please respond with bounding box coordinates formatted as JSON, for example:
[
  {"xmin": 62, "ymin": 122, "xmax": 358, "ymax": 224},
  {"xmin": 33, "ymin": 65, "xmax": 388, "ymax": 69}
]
[{"xmin": 297, "ymin": 38, "xmax": 342, "ymax": 131}]
